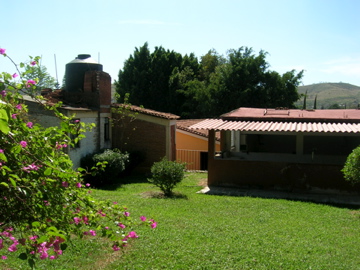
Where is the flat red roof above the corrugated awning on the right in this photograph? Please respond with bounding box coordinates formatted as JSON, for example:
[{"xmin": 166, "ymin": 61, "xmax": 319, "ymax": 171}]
[{"xmin": 220, "ymin": 107, "xmax": 360, "ymax": 123}]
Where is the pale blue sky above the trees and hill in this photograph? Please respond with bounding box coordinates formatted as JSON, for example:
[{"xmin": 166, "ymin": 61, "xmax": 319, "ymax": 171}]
[{"xmin": 0, "ymin": 0, "xmax": 360, "ymax": 86}]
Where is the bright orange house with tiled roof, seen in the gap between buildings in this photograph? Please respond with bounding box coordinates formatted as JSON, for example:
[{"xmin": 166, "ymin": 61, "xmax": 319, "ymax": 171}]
[{"xmin": 176, "ymin": 119, "xmax": 220, "ymax": 170}]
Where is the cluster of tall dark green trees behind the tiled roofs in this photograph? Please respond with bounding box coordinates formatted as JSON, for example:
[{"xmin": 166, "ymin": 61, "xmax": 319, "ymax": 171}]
[{"xmin": 117, "ymin": 43, "xmax": 303, "ymax": 118}]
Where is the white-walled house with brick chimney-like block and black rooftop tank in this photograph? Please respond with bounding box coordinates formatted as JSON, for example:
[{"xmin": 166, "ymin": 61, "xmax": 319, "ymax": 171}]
[{"xmin": 25, "ymin": 54, "xmax": 111, "ymax": 168}]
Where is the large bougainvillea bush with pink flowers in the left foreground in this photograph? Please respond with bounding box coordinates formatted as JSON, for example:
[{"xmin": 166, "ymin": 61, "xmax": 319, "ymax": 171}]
[{"xmin": 0, "ymin": 48, "xmax": 156, "ymax": 267}]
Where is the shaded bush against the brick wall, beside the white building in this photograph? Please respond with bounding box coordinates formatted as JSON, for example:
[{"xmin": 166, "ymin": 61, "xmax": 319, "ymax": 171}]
[{"xmin": 81, "ymin": 149, "xmax": 129, "ymax": 187}]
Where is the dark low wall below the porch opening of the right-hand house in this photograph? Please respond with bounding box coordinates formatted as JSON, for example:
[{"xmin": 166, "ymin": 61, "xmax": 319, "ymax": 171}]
[{"xmin": 208, "ymin": 158, "xmax": 360, "ymax": 194}]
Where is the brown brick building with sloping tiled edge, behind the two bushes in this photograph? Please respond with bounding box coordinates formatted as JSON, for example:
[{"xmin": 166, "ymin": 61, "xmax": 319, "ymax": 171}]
[{"xmin": 112, "ymin": 104, "xmax": 179, "ymax": 172}]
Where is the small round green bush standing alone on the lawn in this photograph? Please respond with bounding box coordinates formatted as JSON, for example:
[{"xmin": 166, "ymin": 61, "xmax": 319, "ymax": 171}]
[{"xmin": 148, "ymin": 158, "xmax": 185, "ymax": 197}]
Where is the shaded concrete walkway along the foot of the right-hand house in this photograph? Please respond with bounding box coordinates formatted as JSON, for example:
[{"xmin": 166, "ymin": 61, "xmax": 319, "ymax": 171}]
[{"xmin": 197, "ymin": 187, "xmax": 360, "ymax": 208}]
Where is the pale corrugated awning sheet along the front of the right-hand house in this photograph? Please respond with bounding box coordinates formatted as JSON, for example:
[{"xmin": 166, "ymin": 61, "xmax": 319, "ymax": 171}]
[{"xmin": 189, "ymin": 119, "xmax": 360, "ymax": 133}]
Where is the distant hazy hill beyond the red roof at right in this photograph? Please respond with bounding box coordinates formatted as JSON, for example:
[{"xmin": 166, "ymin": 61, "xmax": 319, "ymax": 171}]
[{"xmin": 295, "ymin": 83, "xmax": 360, "ymax": 109}]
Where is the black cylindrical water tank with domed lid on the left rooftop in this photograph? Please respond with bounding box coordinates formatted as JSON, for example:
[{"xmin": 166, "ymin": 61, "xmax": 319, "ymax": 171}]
[{"xmin": 65, "ymin": 54, "xmax": 102, "ymax": 92}]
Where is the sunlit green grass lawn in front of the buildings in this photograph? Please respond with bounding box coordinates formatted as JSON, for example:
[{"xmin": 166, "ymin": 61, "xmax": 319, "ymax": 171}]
[{"xmin": 0, "ymin": 173, "xmax": 360, "ymax": 270}]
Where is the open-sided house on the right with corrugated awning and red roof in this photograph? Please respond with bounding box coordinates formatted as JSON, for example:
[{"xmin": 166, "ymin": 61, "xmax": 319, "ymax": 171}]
[{"xmin": 189, "ymin": 108, "xmax": 360, "ymax": 194}]
